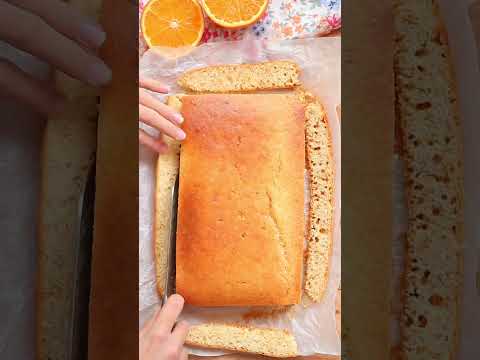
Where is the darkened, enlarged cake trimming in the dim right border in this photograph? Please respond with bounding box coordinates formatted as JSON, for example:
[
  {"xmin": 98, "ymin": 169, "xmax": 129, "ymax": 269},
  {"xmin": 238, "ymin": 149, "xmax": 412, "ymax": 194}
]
[{"xmin": 394, "ymin": 0, "xmax": 463, "ymax": 360}]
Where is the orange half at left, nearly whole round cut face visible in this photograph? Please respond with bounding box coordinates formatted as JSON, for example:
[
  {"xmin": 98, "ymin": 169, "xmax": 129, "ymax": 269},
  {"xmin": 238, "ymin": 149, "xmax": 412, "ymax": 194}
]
[{"xmin": 141, "ymin": 0, "xmax": 204, "ymax": 48}]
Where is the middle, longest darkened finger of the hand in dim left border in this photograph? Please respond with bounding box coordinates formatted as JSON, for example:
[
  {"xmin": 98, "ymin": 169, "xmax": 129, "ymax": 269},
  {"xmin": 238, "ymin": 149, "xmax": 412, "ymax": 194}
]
[{"xmin": 0, "ymin": 1, "xmax": 111, "ymax": 86}]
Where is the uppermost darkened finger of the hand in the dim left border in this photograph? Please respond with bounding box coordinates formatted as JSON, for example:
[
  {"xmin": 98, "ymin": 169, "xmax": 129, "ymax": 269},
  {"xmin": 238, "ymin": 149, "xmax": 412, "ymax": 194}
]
[{"xmin": 8, "ymin": 0, "xmax": 106, "ymax": 49}]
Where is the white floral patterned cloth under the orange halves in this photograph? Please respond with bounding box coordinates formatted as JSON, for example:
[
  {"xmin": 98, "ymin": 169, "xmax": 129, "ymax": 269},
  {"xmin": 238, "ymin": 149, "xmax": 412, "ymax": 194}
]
[{"xmin": 139, "ymin": 0, "xmax": 342, "ymax": 50}]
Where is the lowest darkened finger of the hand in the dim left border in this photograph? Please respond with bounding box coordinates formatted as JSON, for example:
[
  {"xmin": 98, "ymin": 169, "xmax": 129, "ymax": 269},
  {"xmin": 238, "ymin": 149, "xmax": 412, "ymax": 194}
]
[{"xmin": 0, "ymin": 59, "xmax": 65, "ymax": 115}]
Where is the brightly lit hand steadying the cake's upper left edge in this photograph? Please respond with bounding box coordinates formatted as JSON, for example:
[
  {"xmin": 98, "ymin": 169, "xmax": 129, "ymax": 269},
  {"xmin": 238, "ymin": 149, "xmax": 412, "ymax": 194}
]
[{"xmin": 138, "ymin": 78, "xmax": 185, "ymax": 153}]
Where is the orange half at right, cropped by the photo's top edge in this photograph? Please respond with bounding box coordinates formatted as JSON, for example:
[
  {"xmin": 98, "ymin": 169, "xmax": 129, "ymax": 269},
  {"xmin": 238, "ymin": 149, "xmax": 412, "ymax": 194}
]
[{"xmin": 203, "ymin": 0, "xmax": 268, "ymax": 28}]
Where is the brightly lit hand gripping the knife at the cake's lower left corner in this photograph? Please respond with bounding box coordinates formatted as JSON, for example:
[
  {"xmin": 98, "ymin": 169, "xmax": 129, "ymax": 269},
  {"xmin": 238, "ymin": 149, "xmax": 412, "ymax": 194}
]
[{"xmin": 139, "ymin": 295, "xmax": 189, "ymax": 360}]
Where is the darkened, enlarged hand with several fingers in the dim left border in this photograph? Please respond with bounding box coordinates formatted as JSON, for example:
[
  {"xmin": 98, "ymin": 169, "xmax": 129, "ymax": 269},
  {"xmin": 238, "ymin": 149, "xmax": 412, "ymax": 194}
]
[{"xmin": 0, "ymin": 0, "xmax": 112, "ymax": 113}]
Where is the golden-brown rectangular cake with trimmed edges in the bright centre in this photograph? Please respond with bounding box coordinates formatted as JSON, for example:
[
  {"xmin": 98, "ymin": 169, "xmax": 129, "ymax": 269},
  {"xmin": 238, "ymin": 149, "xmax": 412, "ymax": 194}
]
[{"xmin": 176, "ymin": 94, "xmax": 305, "ymax": 306}]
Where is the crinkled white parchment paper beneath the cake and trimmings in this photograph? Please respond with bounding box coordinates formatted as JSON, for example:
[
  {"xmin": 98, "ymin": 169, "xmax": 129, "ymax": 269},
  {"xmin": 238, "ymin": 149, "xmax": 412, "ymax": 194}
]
[{"xmin": 139, "ymin": 38, "xmax": 341, "ymax": 355}]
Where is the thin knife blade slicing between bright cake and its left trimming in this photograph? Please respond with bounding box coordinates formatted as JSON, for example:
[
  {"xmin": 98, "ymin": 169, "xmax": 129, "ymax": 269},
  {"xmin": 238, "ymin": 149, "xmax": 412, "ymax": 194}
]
[{"xmin": 162, "ymin": 175, "xmax": 179, "ymax": 305}]
